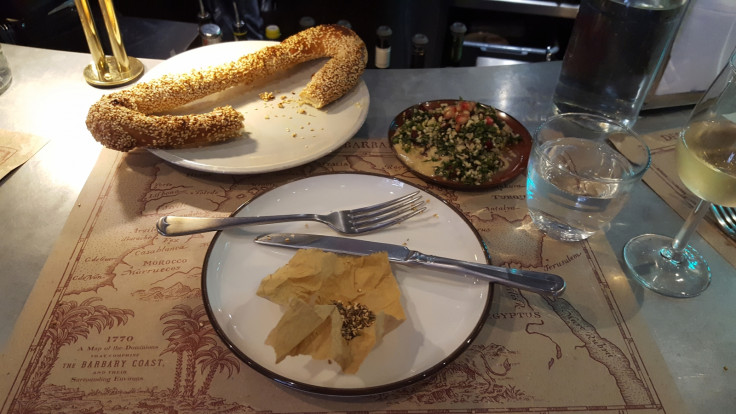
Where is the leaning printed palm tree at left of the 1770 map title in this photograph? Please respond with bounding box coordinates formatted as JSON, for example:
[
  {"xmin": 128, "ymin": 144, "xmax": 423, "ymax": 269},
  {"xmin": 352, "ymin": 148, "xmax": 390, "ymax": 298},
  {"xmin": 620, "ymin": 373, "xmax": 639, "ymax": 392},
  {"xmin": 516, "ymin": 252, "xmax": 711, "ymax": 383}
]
[{"xmin": 24, "ymin": 297, "xmax": 135, "ymax": 397}]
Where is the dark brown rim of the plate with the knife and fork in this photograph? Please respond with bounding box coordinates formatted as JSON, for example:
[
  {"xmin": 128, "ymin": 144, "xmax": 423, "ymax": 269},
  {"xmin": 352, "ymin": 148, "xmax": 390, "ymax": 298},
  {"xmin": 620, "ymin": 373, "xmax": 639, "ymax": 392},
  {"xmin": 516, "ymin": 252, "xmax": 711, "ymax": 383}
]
[{"xmin": 201, "ymin": 172, "xmax": 495, "ymax": 397}]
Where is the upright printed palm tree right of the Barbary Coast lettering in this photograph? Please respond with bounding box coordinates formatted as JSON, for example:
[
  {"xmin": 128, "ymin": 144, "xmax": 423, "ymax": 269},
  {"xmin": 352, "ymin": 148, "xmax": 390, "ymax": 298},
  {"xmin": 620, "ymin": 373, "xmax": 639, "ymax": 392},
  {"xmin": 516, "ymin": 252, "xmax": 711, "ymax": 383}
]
[{"xmin": 161, "ymin": 305, "xmax": 217, "ymax": 398}]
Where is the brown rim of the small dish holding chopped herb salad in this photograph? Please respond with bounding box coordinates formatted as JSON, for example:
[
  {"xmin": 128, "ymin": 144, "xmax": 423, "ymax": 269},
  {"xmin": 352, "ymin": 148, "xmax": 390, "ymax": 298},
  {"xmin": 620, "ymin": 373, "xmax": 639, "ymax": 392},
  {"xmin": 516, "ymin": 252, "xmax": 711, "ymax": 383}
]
[{"xmin": 387, "ymin": 98, "xmax": 533, "ymax": 191}]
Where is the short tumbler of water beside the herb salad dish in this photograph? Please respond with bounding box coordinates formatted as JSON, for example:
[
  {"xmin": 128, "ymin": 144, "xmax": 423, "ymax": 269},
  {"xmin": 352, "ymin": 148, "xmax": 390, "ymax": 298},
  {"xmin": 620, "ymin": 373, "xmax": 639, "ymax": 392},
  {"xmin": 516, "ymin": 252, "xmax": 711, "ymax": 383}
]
[{"xmin": 526, "ymin": 113, "xmax": 650, "ymax": 241}]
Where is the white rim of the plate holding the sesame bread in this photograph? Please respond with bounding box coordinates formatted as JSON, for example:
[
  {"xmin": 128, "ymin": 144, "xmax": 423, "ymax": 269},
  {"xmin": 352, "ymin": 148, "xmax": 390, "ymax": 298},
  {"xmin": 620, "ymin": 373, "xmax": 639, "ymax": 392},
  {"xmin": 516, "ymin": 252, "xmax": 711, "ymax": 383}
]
[{"xmin": 142, "ymin": 40, "xmax": 371, "ymax": 175}]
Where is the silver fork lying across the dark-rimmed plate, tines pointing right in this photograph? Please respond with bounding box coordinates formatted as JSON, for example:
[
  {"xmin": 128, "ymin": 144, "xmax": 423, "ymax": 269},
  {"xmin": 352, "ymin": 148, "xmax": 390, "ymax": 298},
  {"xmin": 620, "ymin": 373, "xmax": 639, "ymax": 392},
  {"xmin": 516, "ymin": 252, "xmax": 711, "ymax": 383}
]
[{"xmin": 156, "ymin": 191, "xmax": 426, "ymax": 236}]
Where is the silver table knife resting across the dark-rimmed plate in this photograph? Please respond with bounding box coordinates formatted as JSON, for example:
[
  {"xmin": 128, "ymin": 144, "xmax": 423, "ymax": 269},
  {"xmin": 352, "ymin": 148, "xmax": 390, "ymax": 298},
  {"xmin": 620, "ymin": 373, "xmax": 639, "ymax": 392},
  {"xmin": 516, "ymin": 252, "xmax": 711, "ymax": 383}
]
[{"xmin": 255, "ymin": 233, "xmax": 566, "ymax": 297}]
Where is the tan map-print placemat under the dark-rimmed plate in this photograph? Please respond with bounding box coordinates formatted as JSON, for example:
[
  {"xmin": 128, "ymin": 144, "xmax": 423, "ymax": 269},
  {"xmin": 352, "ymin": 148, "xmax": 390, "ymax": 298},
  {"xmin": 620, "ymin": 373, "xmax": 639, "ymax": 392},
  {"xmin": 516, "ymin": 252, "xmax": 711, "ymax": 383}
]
[{"xmin": 0, "ymin": 138, "xmax": 684, "ymax": 414}]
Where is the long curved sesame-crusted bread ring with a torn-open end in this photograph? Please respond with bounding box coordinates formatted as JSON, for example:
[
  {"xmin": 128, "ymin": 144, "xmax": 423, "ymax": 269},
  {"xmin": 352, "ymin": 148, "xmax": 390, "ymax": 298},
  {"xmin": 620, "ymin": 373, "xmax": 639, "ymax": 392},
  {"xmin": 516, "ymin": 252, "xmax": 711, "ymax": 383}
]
[{"xmin": 87, "ymin": 25, "xmax": 368, "ymax": 151}]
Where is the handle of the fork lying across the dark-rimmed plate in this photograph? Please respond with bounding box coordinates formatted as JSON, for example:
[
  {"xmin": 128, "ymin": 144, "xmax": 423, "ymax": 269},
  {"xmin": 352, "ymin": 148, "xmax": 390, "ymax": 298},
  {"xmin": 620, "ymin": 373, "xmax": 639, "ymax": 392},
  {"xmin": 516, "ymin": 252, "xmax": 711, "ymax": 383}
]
[{"xmin": 156, "ymin": 214, "xmax": 314, "ymax": 236}]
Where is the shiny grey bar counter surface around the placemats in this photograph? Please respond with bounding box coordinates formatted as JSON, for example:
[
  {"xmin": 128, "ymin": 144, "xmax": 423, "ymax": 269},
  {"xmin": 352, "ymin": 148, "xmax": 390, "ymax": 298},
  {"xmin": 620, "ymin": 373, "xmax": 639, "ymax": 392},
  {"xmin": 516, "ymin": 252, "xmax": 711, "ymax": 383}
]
[{"xmin": 0, "ymin": 44, "xmax": 736, "ymax": 413}]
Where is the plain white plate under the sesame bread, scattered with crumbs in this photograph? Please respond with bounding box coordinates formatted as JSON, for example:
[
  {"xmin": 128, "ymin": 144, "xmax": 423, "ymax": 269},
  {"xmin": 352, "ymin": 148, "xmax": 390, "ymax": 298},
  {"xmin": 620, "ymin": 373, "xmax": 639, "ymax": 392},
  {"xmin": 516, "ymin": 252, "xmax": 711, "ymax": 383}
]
[{"xmin": 143, "ymin": 41, "xmax": 370, "ymax": 174}]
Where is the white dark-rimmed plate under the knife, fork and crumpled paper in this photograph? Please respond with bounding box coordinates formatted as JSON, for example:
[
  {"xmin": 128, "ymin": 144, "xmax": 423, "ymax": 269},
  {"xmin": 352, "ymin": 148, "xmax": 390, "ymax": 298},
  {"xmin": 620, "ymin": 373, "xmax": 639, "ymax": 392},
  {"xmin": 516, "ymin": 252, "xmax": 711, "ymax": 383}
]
[{"xmin": 202, "ymin": 174, "xmax": 491, "ymax": 395}]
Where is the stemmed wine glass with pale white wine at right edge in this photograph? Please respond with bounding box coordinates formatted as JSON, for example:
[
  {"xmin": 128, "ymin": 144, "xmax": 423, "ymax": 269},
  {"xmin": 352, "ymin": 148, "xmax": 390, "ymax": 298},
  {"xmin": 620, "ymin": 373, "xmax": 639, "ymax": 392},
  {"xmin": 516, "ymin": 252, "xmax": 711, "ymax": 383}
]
[{"xmin": 623, "ymin": 49, "xmax": 736, "ymax": 298}]
